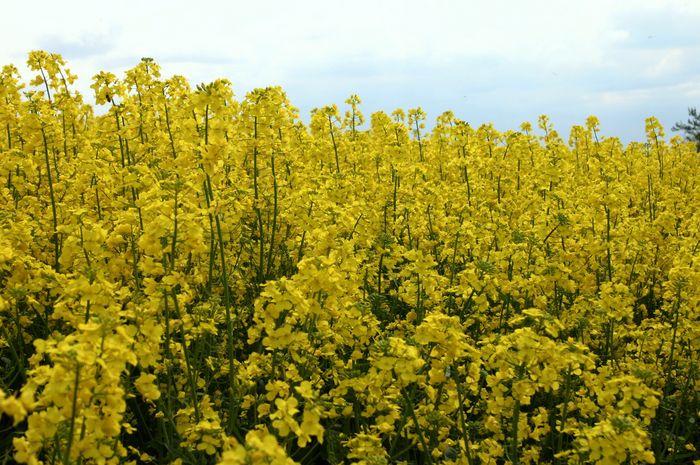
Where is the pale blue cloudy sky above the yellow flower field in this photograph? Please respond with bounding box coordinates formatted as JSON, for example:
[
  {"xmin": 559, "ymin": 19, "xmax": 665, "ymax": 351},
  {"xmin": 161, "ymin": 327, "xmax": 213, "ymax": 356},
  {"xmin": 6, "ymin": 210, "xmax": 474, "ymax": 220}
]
[{"xmin": 0, "ymin": 0, "xmax": 700, "ymax": 142}]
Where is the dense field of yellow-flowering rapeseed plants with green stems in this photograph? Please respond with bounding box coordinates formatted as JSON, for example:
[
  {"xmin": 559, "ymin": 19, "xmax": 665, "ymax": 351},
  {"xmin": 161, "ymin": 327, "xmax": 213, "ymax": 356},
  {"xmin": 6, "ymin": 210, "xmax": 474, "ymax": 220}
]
[{"xmin": 0, "ymin": 52, "xmax": 700, "ymax": 465}]
